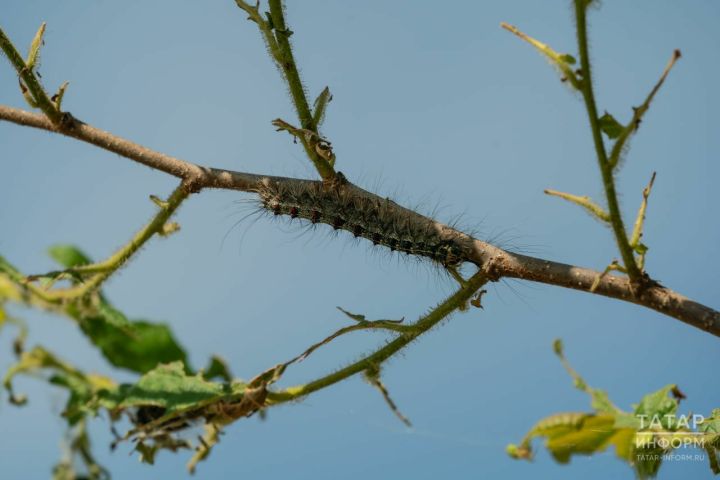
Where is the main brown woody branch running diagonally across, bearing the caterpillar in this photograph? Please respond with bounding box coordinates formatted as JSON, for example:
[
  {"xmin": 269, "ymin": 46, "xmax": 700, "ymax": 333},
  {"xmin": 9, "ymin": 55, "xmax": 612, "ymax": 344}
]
[{"xmin": 0, "ymin": 105, "xmax": 720, "ymax": 336}]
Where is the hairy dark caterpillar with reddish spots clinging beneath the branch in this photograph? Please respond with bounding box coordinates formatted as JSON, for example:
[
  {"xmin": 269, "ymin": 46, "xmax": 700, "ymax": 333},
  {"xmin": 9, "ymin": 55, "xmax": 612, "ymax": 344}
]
[{"xmin": 257, "ymin": 172, "xmax": 468, "ymax": 268}]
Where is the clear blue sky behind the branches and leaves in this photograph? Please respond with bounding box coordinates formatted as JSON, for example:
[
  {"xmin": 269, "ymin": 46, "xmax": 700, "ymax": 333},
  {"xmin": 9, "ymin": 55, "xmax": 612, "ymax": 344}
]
[{"xmin": 0, "ymin": 0, "xmax": 720, "ymax": 480}]
